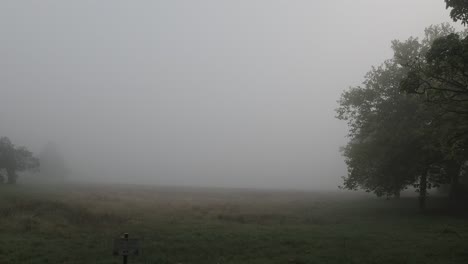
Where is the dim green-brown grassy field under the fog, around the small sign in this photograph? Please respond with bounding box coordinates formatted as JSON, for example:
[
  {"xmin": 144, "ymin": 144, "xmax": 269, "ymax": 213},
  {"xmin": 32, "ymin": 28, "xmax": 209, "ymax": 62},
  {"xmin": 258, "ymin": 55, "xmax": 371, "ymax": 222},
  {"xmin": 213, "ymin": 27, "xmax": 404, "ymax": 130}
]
[{"xmin": 0, "ymin": 185, "xmax": 468, "ymax": 264}]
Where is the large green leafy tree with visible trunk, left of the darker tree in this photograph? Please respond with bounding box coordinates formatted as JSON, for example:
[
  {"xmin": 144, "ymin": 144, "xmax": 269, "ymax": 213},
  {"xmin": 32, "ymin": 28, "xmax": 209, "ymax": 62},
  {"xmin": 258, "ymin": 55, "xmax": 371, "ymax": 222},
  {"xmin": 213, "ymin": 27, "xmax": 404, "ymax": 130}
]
[{"xmin": 337, "ymin": 24, "xmax": 453, "ymax": 208}]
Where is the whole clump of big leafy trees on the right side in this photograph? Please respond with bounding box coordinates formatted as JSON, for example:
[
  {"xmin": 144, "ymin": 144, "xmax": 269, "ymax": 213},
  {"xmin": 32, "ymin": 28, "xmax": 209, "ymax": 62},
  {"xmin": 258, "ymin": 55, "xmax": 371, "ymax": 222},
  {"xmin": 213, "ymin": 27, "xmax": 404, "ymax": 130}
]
[{"xmin": 337, "ymin": 0, "xmax": 468, "ymax": 209}]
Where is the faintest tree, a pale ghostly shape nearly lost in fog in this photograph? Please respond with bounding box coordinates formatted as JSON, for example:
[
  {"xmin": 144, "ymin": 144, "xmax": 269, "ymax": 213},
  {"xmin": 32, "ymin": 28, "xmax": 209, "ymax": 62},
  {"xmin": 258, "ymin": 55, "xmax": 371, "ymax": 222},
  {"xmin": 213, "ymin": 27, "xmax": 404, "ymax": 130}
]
[{"xmin": 39, "ymin": 142, "xmax": 70, "ymax": 181}]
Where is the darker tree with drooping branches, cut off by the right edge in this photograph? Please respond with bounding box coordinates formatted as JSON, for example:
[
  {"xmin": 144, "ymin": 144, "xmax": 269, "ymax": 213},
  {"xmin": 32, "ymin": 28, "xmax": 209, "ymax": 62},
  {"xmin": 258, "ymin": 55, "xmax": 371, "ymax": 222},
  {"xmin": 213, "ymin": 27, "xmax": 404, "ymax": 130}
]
[{"xmin": 395, "ymin": 24, "xmax": 468, "ymax": 198}]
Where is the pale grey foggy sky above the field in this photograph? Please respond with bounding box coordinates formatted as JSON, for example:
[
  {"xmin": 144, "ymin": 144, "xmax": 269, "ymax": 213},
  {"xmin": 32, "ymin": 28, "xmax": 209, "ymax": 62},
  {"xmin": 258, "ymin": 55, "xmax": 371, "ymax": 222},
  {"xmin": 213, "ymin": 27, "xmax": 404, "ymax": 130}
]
[{"xmin": 0, "ymin": 0, "xmax": 458, "ymax": 189}]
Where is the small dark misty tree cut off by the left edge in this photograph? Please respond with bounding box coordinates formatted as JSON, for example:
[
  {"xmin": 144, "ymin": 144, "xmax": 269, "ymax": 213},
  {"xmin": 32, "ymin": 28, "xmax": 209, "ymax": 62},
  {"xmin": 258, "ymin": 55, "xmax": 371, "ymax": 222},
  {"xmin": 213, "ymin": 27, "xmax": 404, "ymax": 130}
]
[{"xmin": 0, "ymin": 137, "xmax": 39, "ymax": 184}]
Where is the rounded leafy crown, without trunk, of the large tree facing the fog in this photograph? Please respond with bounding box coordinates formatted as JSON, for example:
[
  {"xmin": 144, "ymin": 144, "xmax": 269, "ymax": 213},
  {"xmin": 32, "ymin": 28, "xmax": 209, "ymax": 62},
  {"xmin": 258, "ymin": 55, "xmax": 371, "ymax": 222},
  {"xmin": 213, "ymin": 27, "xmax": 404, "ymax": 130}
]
[{"xmin": 337, "ymin": 57, "xmax": 441, "ymax": 196}]
